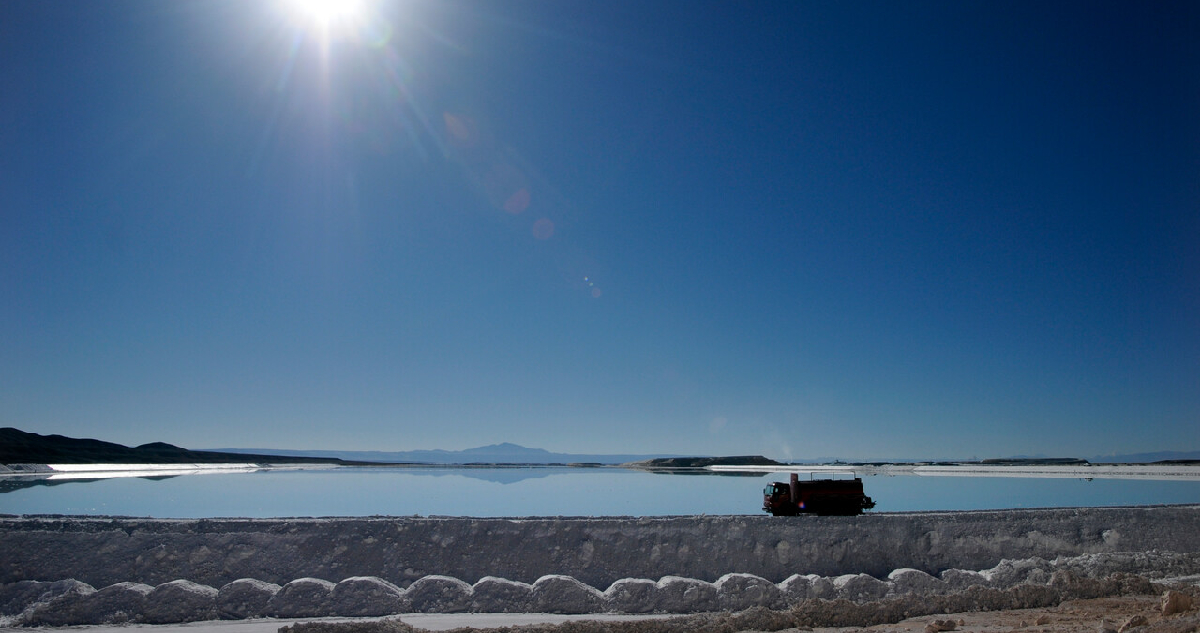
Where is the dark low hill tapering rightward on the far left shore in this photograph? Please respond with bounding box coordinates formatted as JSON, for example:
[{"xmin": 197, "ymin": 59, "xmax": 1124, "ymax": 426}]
[{"xmin": 0, "ymin": 427, "xmax": 344, "ymax": 464}]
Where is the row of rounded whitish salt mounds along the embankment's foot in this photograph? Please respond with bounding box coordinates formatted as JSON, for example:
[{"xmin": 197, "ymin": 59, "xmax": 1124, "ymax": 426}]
[{"xmin": 0, "ymin": 551, "xmax": 1200, "ymax": 626}]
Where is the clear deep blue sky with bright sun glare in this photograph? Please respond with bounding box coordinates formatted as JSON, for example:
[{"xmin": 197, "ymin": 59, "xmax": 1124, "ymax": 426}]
[{"xmin": 0, "ymin": 0, "xmax": 1200, "ymax": 458}]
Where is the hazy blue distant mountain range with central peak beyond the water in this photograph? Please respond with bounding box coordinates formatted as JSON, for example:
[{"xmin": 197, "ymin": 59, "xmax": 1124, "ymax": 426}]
[{"xmin": 207, "ymin": 442, "xmax": 684, "ymax": 465}]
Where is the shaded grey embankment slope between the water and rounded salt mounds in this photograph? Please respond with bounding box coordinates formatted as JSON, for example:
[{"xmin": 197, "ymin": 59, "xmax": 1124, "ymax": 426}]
[{"xmin": 0, "ymin": 506, "xmax": 1200, "ymax": 586}]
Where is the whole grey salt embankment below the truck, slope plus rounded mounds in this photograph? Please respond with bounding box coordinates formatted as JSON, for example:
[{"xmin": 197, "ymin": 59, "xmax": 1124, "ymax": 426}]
[{"xmin": 0, "ymin": 506, "xmax": 1200, "ymax": 625}]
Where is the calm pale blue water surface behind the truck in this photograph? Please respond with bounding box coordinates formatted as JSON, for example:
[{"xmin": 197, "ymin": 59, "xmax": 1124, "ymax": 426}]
[{"xmin": 0, "ymin": 466, "xmax": 1200, "ymax": 518}]
